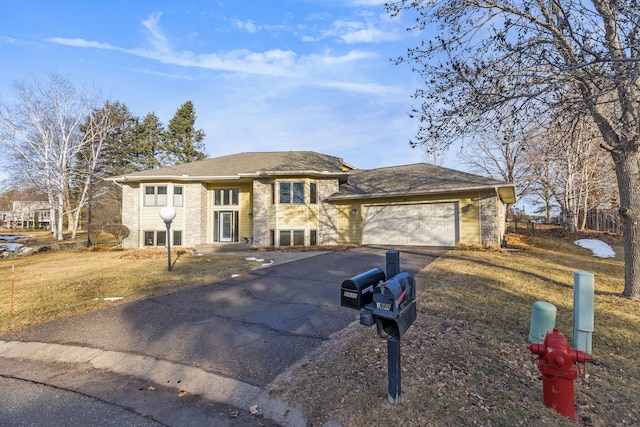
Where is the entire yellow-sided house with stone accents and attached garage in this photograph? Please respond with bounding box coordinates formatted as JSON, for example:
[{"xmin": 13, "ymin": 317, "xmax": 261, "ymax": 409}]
[{"xmin": 108, "ymin": 151, "xmax": 516, "ymax": 248}]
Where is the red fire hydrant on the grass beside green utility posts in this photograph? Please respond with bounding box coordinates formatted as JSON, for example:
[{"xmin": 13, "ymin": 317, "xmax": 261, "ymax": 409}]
[{"xmin": 527, "ymin": 328, "xmax": 591, "ymax": 421}]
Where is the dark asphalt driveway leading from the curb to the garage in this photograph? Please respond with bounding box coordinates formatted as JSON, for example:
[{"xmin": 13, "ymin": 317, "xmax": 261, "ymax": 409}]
[{"xmin": 0, "ymin": 247, "xmax": 445, "ymax": 426}]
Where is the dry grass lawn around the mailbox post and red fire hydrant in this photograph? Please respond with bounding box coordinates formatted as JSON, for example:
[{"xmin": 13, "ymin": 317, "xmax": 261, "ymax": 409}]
[{"xmin": 272, "ymin": 236, "xmax": 640, "ymax": 426}]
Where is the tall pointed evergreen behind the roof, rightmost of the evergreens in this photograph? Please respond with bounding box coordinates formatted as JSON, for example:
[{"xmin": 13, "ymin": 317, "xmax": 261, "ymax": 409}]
[{"xmin": 165, "ymin": 101, "xmax": 207, "ymax": 164}]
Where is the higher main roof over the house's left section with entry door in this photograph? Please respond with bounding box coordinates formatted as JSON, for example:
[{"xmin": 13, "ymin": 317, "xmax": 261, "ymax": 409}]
[{"xmin": 107, "ymin": 151, "xmax": 354, "ymax": 182}]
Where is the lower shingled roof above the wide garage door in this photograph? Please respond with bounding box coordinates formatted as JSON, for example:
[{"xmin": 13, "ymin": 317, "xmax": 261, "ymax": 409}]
[{"xmin": 330, "ymin": 163, "xmax": 516, "ymax": 203}]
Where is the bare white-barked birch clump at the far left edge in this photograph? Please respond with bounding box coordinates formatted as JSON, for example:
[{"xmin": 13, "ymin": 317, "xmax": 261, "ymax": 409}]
[{"xmin": 0, "ymin": 74, "xmax": 105, "ymax": 240}]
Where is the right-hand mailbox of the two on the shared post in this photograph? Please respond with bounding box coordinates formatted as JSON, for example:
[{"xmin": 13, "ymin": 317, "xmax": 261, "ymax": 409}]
[{"xmin": 373, "ymin": 272, "xmax": 417, "ymax": 341}]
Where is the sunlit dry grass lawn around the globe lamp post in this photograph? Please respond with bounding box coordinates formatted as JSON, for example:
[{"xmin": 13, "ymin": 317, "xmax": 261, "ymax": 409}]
[{"xmin": 0, "ymin": 239, "xmax": 268, "ymax": 332}]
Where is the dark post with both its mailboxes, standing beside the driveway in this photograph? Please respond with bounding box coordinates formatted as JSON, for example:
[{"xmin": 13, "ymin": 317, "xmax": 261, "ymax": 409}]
[{"xmin": 340, "ymin": 250, "xmax": 417, "ymax": 404}]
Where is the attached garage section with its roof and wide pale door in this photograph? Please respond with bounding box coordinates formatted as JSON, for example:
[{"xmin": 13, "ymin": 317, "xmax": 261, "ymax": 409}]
[{"xmin": 327, "ymin": 163, "xmax": 516, "ymax": 251}]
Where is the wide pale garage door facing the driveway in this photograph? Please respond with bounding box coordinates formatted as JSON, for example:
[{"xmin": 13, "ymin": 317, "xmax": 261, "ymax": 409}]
[{"xmin": 364, "ymin": 203, "xmax": 458, "ymax": 246}]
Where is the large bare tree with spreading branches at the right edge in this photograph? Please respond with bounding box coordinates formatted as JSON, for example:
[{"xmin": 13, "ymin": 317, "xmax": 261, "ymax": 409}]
[{"xmin": 387, "ymin": 0, "xmax": 640, "ymax": 299}]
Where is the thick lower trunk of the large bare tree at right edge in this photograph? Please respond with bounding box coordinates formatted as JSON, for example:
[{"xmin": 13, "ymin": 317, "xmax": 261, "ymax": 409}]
[{"xmin": 612, "ymin": 150, "xmax": 640, "ymax": 300}]
